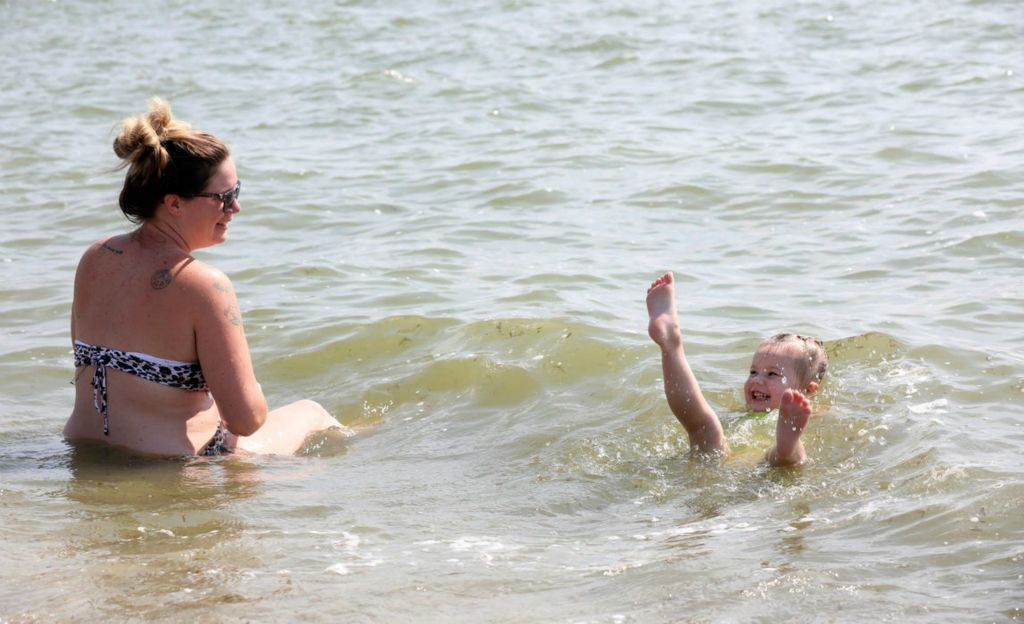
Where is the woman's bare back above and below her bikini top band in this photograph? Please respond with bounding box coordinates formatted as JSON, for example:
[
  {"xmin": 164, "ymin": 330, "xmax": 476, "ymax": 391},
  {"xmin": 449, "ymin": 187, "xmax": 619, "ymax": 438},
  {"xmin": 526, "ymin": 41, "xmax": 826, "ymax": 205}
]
[{"xmin": 65, "ymin": 231, "xmax": 219, "ymax": 454}]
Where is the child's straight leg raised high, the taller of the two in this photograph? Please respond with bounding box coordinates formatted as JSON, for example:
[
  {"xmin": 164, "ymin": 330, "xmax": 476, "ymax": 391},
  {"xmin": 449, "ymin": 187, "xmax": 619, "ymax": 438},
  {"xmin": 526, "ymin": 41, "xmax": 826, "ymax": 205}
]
[{"xmin": 647, "ymin": 273, "xmax": 729, "ymax": 453}]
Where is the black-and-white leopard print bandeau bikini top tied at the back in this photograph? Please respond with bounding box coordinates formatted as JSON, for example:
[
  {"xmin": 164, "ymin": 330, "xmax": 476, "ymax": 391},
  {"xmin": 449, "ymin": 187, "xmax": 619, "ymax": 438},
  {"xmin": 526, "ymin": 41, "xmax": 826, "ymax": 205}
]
[{"xmin": 75, "ymin": 340, "xmax": 209, "ymax": 435}]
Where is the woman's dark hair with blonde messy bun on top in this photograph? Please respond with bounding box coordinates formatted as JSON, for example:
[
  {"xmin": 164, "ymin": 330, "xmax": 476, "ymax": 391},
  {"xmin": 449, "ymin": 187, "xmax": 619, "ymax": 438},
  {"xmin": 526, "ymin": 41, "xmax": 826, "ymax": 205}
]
[{"xmin": 114, "ymin": 97, "xmax": 230, "ymax": 223}]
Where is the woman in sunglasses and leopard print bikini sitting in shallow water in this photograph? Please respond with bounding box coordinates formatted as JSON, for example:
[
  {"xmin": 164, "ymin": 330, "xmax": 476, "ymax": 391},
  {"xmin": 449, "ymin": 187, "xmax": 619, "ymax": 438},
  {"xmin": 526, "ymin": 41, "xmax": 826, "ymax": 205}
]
[{"xmin": 65, "ymin": 99, "xmax": 338, "ymax": 456}]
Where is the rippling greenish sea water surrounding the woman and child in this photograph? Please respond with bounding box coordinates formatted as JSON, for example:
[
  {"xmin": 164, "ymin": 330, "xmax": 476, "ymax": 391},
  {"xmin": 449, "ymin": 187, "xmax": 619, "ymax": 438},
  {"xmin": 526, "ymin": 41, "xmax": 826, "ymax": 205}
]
[{"xmin": 0, "ymin": 0, "xmax": 1024, "ymax": 623}]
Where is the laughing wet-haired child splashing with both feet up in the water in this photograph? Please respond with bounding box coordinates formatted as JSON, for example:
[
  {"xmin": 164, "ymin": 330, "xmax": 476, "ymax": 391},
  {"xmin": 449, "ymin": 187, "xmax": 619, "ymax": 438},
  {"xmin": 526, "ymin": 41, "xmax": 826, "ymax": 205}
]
[{"xmin": 647, "ymin": 273, "xmax": 828, "ymax": 466}]
